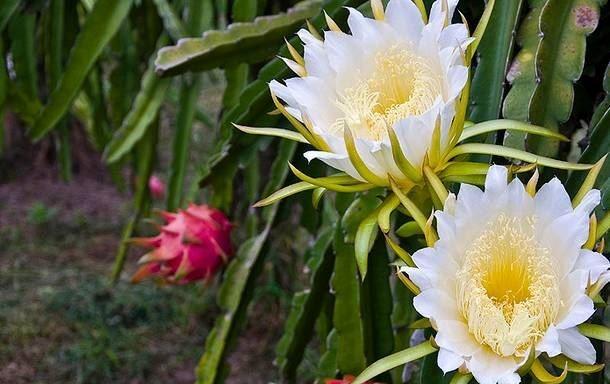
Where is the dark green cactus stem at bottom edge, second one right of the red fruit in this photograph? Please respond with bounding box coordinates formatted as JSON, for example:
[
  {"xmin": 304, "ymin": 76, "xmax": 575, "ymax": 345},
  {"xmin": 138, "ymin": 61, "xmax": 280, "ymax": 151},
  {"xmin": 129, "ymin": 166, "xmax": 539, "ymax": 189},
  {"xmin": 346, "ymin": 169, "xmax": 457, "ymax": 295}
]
[{"xmin": 276, "ymin": 226, "xmax": 334, "ymax": 382}]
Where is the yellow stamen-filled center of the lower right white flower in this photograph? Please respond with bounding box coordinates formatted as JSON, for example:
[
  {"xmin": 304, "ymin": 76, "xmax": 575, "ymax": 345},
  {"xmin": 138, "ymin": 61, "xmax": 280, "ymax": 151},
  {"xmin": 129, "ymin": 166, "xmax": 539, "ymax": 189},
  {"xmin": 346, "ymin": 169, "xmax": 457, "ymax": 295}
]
[{"xmin": 457, "ymin": 215, "xmax": 559, "ymax": 357}]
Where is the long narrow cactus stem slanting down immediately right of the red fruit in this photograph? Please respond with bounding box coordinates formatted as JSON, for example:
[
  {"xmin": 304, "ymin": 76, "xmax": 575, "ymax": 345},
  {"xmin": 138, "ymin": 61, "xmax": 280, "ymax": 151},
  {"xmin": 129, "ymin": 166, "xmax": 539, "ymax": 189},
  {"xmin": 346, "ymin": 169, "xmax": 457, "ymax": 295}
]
[{"xmin": 197, "ymin": 141, "xmax": 296, "ymax": 384}]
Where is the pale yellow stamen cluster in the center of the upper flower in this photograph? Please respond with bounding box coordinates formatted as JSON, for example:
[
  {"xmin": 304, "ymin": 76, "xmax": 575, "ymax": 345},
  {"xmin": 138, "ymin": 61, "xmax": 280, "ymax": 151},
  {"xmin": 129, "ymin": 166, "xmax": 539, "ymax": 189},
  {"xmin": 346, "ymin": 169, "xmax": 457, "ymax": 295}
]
[{"xmin": 333, "ymin": 46, "xmax": 443, "ymax": 140}]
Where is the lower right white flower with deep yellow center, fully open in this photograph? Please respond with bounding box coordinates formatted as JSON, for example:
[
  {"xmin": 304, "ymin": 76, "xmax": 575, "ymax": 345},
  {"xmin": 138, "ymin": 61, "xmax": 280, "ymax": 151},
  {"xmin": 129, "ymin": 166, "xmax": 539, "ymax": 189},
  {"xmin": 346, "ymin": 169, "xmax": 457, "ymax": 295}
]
[{"xmin": 403, "ymin": 166, "xmax": 610, "ymax": 384}]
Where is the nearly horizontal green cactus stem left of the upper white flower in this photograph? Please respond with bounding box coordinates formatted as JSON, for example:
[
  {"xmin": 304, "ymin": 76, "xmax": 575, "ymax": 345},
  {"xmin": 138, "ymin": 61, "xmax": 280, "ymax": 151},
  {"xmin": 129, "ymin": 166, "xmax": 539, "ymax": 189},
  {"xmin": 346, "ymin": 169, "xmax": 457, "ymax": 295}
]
[{"xmin": 155, "ymin": 0, "xmax": 321, "ymax": 76}]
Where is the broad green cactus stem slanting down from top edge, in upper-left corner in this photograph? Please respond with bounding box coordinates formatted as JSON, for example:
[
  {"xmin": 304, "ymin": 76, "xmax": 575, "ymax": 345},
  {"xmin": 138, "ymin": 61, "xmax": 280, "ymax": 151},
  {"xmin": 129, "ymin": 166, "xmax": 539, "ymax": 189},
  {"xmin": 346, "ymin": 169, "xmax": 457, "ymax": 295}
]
[{"xmin": 28, "ymin": 0, "xmax": 131, "ymax": 140}]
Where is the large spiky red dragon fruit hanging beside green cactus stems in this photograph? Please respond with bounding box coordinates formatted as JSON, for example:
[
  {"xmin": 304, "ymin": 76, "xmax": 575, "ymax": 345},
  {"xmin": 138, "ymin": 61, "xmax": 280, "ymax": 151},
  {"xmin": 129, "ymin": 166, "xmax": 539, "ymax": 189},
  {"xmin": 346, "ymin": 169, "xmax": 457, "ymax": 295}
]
[{"xmin": 132, "ymin": 204, "xmax": 233, "ymax": 284}]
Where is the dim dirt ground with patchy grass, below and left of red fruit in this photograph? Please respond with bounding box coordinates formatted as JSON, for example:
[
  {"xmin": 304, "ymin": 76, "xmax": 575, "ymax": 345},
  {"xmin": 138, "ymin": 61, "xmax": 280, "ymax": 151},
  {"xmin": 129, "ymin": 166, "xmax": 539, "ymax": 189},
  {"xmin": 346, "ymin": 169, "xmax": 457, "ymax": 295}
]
[{"xmin": 0, "ymin": 172, "xmax": 281, "ymax": 384}]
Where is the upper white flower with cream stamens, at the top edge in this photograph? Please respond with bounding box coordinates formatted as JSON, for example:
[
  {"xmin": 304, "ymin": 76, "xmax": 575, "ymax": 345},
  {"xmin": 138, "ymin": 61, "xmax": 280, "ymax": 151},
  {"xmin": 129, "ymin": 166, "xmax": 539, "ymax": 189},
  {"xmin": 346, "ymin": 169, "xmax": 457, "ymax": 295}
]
[{"xmin": 270, "ymin": 0, "xmax": 471, "ymax": 185}]
